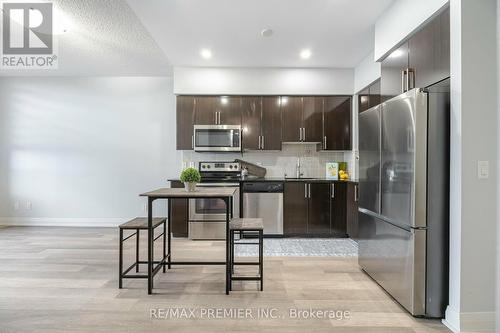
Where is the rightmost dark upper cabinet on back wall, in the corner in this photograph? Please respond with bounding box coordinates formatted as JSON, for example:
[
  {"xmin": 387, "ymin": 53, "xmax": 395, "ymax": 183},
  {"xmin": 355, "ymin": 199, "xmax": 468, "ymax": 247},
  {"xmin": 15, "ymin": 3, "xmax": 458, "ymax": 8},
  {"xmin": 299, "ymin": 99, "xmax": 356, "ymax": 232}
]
[{"xmin": 322, "ymin": 96, "xmax": 352, "ymax": 150}]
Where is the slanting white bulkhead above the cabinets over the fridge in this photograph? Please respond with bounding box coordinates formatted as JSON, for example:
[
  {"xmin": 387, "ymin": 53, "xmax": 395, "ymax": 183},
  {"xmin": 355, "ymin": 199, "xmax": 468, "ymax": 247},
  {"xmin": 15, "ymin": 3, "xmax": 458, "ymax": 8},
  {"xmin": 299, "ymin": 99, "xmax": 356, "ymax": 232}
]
[{"xmin": 374, "ymin": 0, "xmax": 450, "ymax": 60}]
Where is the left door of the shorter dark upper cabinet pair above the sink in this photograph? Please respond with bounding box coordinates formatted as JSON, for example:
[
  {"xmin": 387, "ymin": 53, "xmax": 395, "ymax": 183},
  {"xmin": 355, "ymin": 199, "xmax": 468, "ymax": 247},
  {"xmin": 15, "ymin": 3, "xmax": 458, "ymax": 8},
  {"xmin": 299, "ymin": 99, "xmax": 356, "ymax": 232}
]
[{"xmin": 280, "ymin": 96, "xmax": 302, "ymax": 142}]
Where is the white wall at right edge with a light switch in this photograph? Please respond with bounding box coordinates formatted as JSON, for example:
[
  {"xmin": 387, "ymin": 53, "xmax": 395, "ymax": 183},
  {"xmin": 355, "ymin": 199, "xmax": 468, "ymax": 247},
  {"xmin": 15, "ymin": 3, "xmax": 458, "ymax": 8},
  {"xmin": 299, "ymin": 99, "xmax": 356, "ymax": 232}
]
[{"xmin": 446, "ymin": 0, "xmax": 498, "ymax": 332}]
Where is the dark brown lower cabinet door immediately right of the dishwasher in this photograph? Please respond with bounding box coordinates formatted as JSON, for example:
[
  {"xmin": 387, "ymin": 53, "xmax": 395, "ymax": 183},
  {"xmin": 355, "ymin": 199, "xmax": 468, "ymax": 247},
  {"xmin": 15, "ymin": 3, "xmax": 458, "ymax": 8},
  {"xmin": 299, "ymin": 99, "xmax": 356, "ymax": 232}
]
[{"xmin": 283, "ymin": 182, "xmax": 307, "ymax": 235}]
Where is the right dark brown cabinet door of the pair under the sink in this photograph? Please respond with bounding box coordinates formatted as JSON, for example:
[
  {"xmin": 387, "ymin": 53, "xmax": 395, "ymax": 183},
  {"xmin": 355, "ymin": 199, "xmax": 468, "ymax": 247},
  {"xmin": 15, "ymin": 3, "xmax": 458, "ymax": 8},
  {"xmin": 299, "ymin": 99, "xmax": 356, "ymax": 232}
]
[{"xmin": 307, "ymin": 183, "xmax": 331, "ymax": 236}]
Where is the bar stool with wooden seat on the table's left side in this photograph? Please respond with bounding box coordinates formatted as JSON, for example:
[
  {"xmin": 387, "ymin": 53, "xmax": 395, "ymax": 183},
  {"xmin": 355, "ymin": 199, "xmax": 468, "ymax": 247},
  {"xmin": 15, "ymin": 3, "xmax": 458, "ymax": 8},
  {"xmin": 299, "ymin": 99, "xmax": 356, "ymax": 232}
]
[{"xmin": 118, "ymin": 217, "xmax": 167, "ymax": 289}]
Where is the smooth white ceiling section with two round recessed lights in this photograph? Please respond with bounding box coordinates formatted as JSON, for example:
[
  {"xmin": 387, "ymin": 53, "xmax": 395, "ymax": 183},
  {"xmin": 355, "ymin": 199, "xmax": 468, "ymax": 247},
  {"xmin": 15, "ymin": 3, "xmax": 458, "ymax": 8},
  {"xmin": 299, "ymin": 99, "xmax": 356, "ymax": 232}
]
[{"xmin": 127, "ymin": 0, "xmax": 393, "ymax": 67}]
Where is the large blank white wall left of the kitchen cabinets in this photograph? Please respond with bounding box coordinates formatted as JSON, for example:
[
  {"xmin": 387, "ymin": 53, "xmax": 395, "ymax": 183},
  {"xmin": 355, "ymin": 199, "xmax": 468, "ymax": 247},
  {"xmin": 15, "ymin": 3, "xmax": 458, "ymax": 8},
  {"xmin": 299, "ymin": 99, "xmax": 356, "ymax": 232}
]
[{"xmin": 0, "ymin": 77, "xmax": 181, "ymax": 225}]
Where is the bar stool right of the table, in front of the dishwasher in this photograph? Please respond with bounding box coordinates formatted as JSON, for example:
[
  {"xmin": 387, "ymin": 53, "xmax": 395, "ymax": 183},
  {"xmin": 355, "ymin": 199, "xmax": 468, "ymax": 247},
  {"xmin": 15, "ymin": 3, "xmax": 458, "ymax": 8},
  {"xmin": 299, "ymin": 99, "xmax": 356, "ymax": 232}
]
[{"xmin": 229, "ymin": 218, "xmax": 264, "ymax": 291}]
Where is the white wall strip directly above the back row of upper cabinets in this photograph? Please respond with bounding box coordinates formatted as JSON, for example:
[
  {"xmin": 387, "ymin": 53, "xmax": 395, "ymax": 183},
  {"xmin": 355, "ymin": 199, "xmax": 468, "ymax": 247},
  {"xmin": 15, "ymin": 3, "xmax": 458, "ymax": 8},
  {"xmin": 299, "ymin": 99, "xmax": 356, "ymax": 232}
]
[{"xmin": 174, "ymin": 67, "xmax": 354, "ymax": 95}]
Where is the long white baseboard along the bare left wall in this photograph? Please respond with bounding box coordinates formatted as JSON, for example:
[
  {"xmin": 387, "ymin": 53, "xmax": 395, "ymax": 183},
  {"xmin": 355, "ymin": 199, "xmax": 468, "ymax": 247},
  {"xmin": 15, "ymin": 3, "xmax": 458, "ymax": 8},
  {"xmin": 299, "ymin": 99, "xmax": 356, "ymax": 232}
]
[{"xmin": 0, "ymin": 217, "xmax": 130, "ymax": 228}]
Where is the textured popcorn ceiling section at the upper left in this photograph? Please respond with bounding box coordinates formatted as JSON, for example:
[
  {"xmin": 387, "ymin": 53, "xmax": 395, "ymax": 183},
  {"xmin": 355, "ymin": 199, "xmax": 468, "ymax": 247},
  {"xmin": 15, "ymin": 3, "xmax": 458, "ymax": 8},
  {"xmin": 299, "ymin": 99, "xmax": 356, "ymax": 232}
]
[{"xmin": 0, "ymin": 0, "xmax": 172, "ymax": 76}]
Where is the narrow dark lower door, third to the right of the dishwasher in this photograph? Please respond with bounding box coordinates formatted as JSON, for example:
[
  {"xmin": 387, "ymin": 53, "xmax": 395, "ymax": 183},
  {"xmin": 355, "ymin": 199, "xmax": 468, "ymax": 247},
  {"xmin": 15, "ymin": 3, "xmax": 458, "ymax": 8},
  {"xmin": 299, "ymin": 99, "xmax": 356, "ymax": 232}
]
[{"xmin": 330, "ymin": 182, "xmax": 349, "ymax": 237}]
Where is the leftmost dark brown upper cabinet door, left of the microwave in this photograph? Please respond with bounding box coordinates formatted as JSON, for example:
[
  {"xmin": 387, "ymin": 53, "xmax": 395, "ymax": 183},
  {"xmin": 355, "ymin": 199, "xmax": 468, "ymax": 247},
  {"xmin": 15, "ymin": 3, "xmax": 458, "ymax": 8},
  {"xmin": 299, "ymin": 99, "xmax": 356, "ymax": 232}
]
[{"xmin": 176, "ymin": 96, "xmax": 195, "ymax": 150}]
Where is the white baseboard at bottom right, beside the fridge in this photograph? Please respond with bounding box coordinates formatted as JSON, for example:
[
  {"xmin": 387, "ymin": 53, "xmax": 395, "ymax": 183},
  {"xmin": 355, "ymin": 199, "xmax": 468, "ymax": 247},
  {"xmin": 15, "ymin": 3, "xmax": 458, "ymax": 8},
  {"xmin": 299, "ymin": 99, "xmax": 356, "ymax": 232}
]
[{"xmin": 443, "ymin": 306, "xmax": 495, "ymax": 333}]
